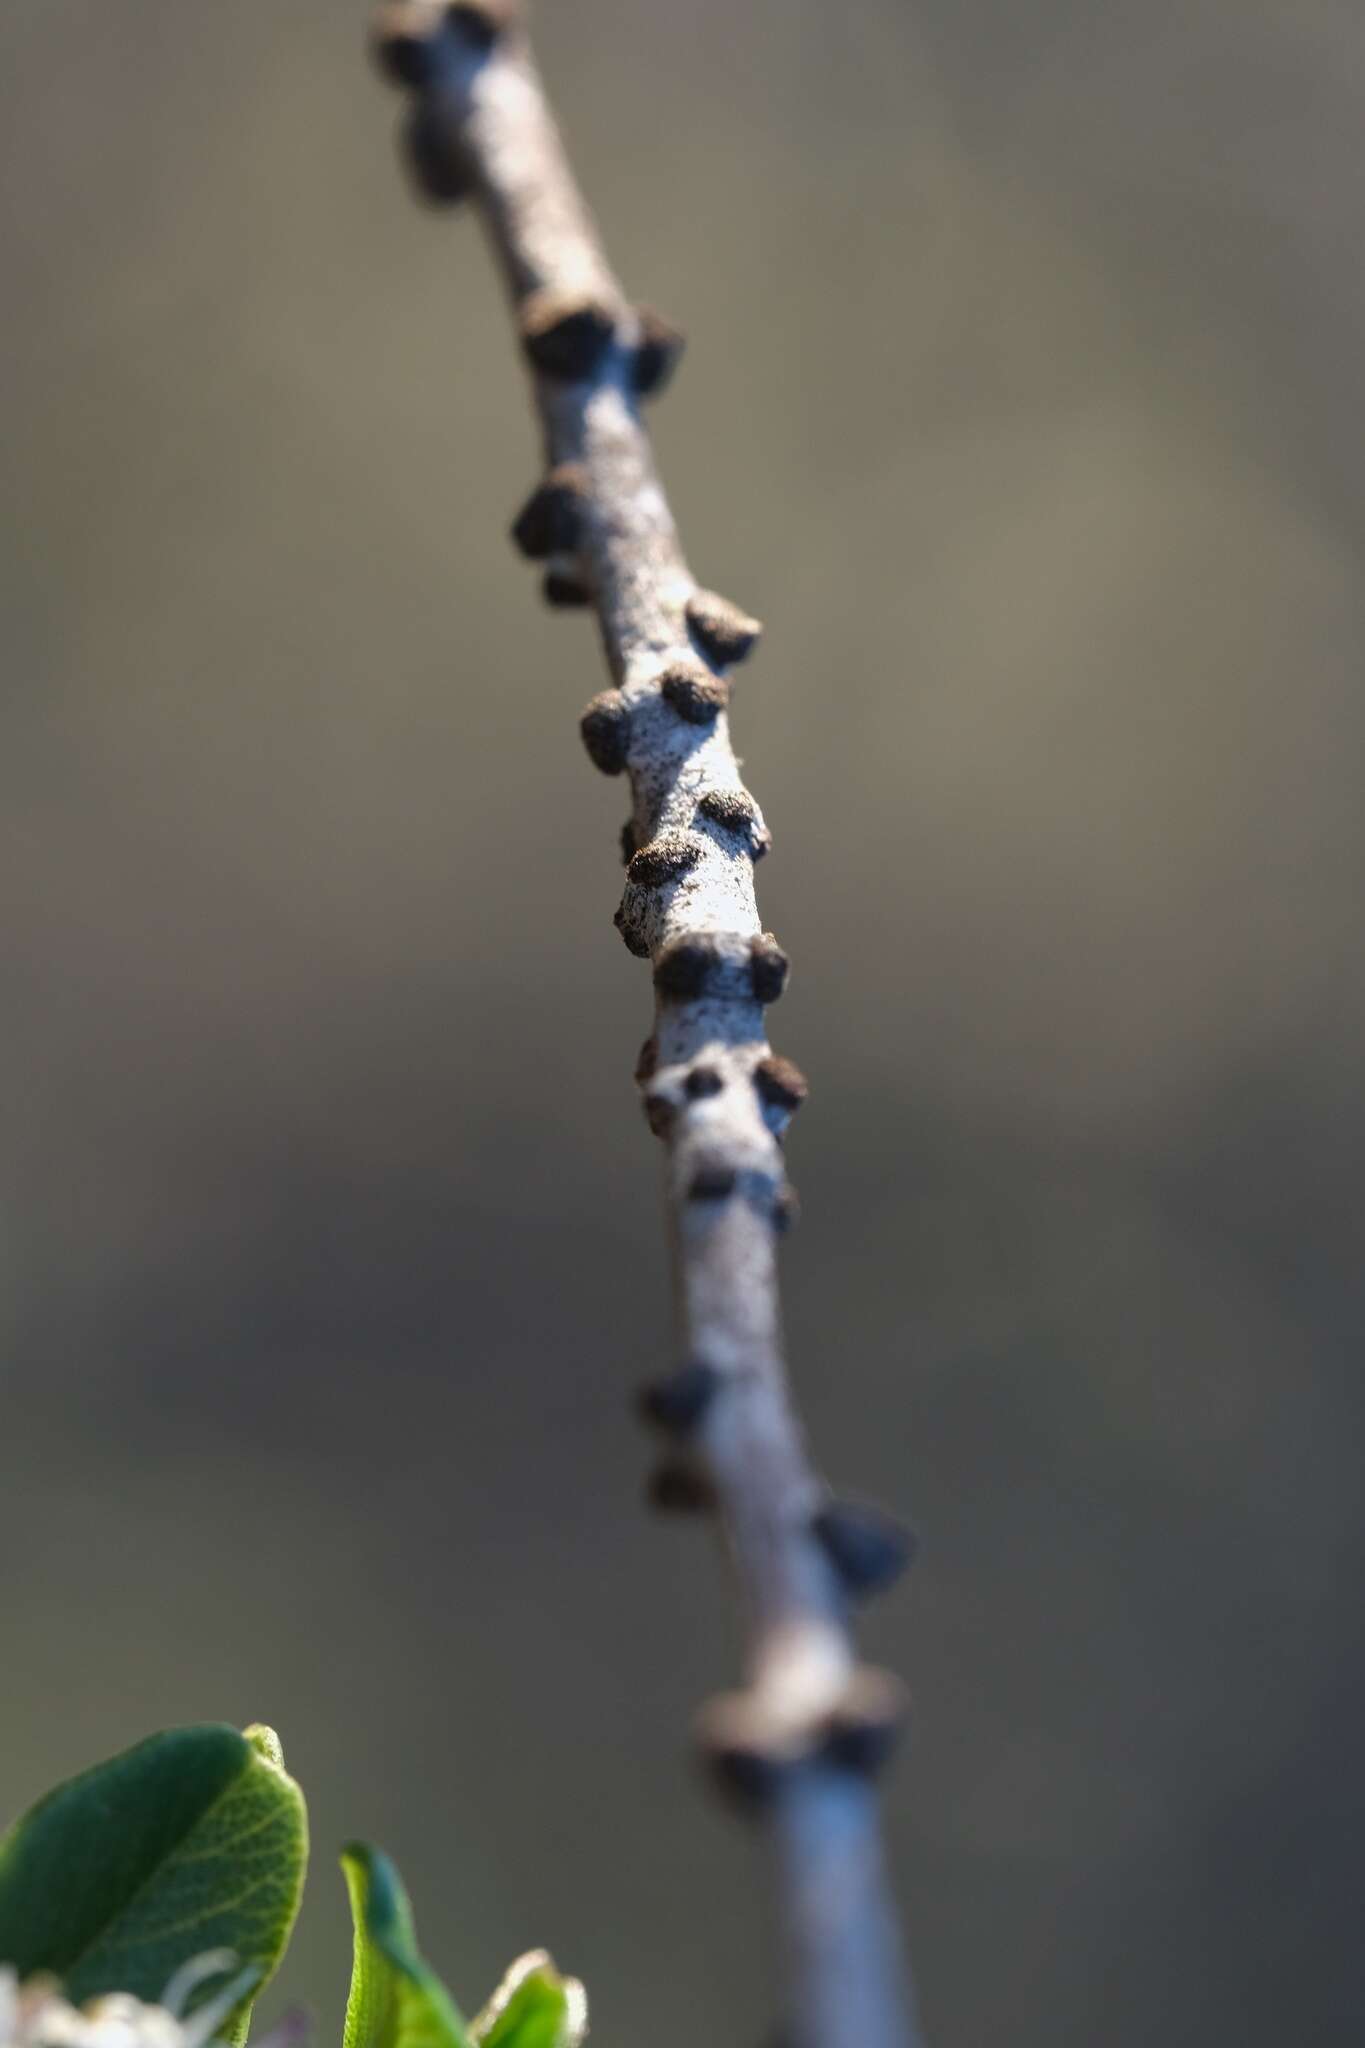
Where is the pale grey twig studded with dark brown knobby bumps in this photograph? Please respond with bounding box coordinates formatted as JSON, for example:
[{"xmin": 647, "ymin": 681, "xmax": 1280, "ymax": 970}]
[{"xmin": 375, "ymin": 0, "xmax": 915, "ymax": 2048}]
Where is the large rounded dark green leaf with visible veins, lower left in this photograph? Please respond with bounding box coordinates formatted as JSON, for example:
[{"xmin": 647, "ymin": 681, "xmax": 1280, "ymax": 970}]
[{"xmin": 0, "ymin": 1722, "xmax": 307, "ymax": 2044}]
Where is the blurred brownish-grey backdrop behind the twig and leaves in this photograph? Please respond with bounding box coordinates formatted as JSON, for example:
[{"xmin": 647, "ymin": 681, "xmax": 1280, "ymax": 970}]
[{"xmin": 0, "ymin": 0, "xmax": 1365, "ymax": 2048}]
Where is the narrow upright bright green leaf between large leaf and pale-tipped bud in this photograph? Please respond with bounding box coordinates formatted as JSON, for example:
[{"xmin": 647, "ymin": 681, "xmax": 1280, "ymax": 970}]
[{"xmin": 342, "ymin": 1841, "xmax": 469, "ymax": 2048}]
